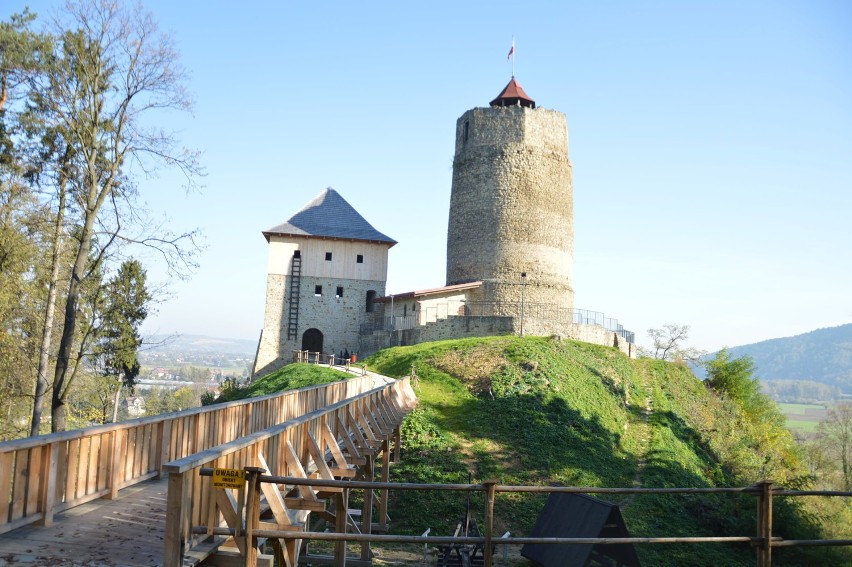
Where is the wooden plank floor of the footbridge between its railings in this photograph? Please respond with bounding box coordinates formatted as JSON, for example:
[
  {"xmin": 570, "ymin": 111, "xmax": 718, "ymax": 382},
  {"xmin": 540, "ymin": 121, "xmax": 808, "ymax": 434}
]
[{"xmin": 0, "ymin": 479, "xmax": 168, "ymax": 567}]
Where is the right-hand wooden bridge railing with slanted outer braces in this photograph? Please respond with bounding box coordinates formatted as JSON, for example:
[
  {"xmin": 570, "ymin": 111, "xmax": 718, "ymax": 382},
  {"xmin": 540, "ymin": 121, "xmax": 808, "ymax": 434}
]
[{"xmin": 163, "ymin": 378, "xmax": 415, "ymax": 567}]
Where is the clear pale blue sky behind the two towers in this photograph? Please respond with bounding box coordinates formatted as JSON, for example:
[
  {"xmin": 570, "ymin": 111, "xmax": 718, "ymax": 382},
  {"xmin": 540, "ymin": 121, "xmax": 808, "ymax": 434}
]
[{"xmin": 6, "ymin": 0, "xmax": 852, "ymax": 350}]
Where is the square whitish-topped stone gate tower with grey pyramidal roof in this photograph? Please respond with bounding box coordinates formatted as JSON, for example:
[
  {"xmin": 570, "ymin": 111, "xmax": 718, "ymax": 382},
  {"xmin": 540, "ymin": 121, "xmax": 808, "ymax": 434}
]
[{"xmin": 254, "ymin": 187, "xmax": 396, "ymax": 374}]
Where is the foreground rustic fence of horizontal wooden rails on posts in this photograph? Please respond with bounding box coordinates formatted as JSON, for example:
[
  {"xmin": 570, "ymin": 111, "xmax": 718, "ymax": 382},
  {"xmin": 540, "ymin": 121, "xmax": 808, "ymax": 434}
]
[{"xmin": 208, "ymin": 480, "xmax": 852, "ymax": 567}]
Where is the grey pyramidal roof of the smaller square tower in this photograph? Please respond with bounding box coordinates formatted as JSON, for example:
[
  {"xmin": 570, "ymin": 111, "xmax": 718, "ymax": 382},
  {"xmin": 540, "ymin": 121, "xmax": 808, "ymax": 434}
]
[{"xmin": 263, "ymin": 187, "xmax": 396, "ymax": 246}]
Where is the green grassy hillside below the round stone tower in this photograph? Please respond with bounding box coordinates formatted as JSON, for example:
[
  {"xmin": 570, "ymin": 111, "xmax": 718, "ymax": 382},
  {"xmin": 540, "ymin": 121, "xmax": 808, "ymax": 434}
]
[{"xmin": 367, "ymin": 337, "xmax": 848, "ymax": 566}]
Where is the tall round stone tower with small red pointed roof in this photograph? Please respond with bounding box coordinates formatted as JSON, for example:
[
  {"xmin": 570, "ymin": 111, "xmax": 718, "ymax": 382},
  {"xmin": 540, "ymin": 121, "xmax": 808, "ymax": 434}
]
[{"xmin": 447, "ymin": 77, "xmax": 574, "ymax": 310}]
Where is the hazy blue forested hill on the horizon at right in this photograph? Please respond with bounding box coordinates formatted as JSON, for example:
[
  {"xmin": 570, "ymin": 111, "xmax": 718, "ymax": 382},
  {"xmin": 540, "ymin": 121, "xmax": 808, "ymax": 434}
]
[{"xmin": 704, "ymin": 324, "xmax": 852, "ymax": 394}]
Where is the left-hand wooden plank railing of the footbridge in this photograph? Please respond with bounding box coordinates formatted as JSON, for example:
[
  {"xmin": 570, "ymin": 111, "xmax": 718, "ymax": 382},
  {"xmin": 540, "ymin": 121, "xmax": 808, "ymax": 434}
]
[{"xmin": 0, "ymin": 375, "xmax": 390, "ymax": 533}]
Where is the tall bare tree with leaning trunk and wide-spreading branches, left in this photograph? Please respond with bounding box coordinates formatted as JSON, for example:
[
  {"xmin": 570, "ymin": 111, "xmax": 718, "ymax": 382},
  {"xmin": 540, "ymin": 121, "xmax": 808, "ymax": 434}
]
[{"xmin": 34, "ymin": 0, "xmax": 201, "ymax": 431}]
